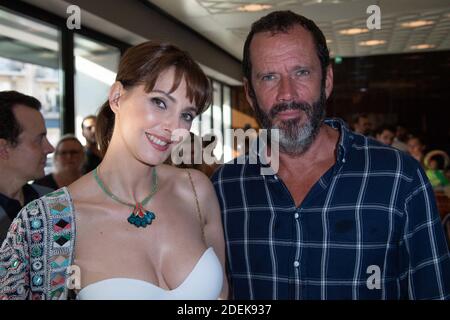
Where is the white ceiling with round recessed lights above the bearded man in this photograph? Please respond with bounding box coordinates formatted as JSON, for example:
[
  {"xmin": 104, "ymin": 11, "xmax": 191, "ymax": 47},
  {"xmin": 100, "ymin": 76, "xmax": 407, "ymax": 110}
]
[{"xmin": 147, "ymin": 0, "xmax": 450, "ymax": 59}]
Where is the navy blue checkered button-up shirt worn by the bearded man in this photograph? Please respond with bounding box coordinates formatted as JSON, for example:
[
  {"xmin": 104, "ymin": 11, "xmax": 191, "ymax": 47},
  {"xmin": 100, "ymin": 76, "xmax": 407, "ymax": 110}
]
[{"xmin": 212, "ymin": 119, "xmax": 450, "ymax": 299}]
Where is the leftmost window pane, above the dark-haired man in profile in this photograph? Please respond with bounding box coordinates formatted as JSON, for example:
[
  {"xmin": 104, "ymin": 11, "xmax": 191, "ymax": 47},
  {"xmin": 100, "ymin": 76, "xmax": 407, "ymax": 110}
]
[{"xmin": 0, "ymin": 9, "xmax": 63, "ymax": 145}]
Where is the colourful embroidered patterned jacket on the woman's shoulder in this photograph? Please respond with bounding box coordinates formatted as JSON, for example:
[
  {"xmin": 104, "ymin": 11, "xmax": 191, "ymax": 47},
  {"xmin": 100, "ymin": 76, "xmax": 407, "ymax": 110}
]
[{"xmin": 0, "ymin": 188, "xmax": 75, "ymax": 300}]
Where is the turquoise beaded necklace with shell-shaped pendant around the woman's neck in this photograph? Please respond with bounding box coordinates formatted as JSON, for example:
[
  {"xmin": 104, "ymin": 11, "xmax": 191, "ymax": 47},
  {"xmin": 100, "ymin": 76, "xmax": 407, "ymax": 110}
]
[{"xmin": 94, "ymin": 167, "xmax": 158, "ymax": 228}]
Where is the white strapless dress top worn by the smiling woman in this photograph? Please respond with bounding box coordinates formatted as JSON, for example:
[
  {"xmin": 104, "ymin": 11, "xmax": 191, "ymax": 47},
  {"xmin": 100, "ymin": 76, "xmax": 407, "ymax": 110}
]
[{"xmin": 77, "ymin": 247, "xmax": 223, "ymax": 300}]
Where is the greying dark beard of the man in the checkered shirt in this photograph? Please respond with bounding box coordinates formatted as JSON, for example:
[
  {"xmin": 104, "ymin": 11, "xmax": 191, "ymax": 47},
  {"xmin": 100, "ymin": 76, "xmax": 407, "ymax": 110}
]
[{"xmin": 253, "ymin": 87, "xmax": 326, "ymax": 156}]
